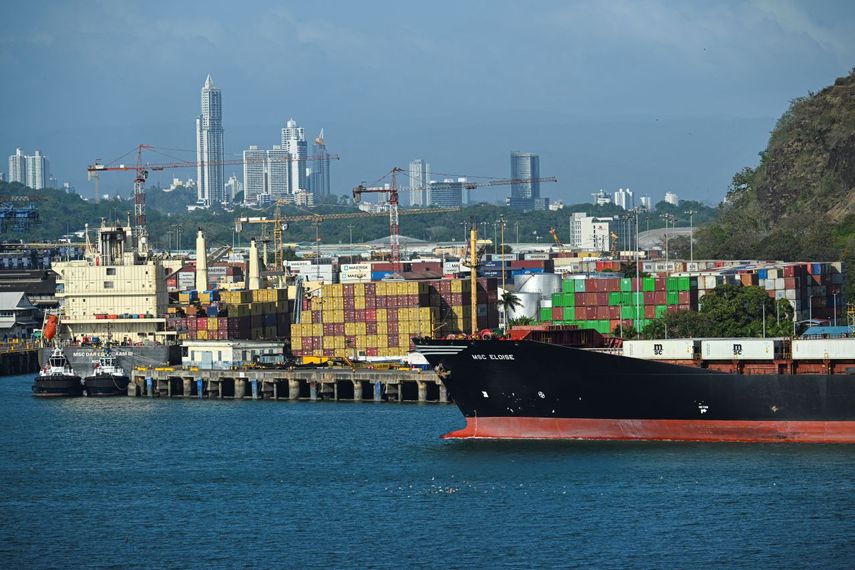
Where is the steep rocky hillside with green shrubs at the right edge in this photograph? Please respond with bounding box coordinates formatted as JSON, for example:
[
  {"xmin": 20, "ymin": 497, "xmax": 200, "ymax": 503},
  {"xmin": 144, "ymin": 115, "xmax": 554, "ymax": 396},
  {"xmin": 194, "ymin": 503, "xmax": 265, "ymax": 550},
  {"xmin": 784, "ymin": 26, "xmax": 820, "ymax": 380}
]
[{"xmin": 695, "ymin": 69, "xmax": 855, "ymax": 301}]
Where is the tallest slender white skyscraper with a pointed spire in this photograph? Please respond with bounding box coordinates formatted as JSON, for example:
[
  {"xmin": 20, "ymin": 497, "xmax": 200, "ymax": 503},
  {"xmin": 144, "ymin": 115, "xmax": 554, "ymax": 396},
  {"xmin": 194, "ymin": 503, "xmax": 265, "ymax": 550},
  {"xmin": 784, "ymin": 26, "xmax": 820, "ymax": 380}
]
[{"xmin": 196, "ymin": 73, "xmax": 228, "ymax": 206}]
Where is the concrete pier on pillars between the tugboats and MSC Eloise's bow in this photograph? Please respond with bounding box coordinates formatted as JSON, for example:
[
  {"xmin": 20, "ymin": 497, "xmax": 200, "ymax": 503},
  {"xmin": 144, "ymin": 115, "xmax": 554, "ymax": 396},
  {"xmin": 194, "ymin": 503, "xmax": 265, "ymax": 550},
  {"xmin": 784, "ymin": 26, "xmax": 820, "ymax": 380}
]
[{"xmin": 128, "ymin": 368, "xmax": 449, "ymax": 403}]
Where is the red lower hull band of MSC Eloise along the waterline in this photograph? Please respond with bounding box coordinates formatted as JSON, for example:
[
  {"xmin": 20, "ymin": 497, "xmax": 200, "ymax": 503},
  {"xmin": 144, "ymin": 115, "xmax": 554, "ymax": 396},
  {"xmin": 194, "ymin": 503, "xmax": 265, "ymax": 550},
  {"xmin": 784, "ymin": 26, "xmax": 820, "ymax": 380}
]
[{"xmin": 443, "ymin": 417, "xmax": 855, "ymax": 444}]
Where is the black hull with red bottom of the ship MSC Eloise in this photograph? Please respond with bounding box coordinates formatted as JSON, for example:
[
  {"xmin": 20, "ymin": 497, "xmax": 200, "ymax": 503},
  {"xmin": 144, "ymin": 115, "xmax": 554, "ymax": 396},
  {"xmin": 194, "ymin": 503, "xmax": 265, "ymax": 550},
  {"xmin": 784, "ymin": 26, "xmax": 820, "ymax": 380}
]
[{"xmin": 414, "ymin": 331, "xmax": 855, "ymax": 443}]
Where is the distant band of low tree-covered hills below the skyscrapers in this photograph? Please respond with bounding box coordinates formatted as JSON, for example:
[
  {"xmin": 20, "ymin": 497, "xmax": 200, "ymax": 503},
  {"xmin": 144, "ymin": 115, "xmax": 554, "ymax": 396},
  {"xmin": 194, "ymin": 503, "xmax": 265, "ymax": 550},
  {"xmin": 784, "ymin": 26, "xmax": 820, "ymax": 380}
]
[{"xmin": 0, "ymin": 183, "xmax": 715, "ymax": 249}]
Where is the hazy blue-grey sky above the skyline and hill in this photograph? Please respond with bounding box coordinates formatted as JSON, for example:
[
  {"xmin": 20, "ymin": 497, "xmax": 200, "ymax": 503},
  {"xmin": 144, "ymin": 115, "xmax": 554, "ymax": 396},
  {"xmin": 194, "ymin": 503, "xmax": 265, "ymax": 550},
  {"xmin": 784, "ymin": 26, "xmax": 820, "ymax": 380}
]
[{"xmin": 0, "ymin": 0, "xmax": 855, "ymax": 203}]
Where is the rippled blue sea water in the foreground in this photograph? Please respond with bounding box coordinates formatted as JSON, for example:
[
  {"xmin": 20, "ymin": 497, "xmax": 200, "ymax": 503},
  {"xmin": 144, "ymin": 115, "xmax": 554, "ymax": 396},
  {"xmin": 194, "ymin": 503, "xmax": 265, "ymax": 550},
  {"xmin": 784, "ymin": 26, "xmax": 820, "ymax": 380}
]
[{"xmin": 0, "ymin": 376, "xmax": 855, "ymax": 568}]
